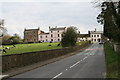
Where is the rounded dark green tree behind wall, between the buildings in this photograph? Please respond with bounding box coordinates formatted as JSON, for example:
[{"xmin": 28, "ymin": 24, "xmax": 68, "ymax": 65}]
[{"xmin": 61, "ymin": 27, "xmax": 78, "ymax": 47}]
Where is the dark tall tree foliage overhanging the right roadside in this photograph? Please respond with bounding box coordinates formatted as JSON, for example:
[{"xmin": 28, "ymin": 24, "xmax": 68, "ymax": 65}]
[{"xmin": 97, "ymin": 0, "xmax": 120, "ymax": 42}]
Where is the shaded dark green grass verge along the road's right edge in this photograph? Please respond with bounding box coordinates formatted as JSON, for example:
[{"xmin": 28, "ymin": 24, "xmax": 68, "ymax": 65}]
[{"xmin": 104, "ymin": 43, "xmax": 118, "ymax": 78}]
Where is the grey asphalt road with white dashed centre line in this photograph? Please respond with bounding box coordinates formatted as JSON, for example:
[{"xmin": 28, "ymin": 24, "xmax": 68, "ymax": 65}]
[{"xmin": 12, "ymin": 43, "xmax": 105, "ymax": 80}]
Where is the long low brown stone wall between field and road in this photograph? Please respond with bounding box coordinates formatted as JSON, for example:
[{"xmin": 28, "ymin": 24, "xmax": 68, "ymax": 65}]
[{"xmin": 2, "ymin": 43, "xmax": 89, "ymax": 72}]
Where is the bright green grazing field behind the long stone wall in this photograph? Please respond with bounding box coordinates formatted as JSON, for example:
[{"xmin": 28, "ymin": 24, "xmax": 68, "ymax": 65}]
[{"xmin": 2, "ymin": 42, "xmax": 62, "ymax": 55}]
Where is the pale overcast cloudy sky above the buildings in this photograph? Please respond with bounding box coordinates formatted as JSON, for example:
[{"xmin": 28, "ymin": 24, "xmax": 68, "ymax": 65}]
[{"xmin": 0, "ymin": 0, "xmax": 102, "ymax": 38}]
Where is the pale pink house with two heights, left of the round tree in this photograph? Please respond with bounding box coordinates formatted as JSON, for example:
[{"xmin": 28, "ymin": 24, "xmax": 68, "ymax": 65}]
[{"xmin": 39, "ymin": 26, "xmax": 66, "ymax": 42}]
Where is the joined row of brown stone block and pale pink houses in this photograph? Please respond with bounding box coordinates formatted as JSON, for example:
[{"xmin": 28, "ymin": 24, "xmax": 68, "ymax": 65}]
[{"xmin": 24, "ymin": 26, "xmax": 66, "ymax": 42}]
